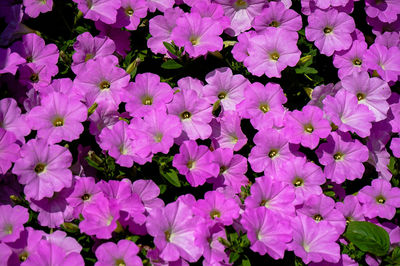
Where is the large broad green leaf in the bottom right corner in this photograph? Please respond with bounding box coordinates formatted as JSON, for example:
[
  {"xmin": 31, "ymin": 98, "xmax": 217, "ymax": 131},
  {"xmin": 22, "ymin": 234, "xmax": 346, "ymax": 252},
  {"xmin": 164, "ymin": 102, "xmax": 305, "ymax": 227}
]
[{"xmin": 344, "ymin": 221, "xmax": 390, "ymax": 256}]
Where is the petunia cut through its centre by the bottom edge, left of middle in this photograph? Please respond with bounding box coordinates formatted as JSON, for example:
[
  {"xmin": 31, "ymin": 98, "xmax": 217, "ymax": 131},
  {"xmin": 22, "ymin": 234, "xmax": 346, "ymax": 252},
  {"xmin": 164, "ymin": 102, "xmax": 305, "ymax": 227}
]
[{"xmin": 95, "ymin": 239, "xmax": 143, "ymax": 266}]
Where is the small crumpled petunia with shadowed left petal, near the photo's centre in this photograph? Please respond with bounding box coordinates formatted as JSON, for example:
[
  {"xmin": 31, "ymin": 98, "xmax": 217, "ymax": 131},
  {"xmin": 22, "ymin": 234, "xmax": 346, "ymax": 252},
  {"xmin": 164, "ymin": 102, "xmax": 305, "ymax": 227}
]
[{"xmin": 211, "ymin": 111, "xmax": 247, "ymax": 151}]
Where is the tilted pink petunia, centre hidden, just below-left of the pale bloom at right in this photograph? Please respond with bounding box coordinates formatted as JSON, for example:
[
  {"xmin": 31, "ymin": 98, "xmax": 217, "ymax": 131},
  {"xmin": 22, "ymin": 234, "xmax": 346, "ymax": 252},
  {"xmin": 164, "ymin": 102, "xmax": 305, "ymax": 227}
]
[{"xmin": 323, "ymin": 89, "xmax": 375, "ymax": 138}]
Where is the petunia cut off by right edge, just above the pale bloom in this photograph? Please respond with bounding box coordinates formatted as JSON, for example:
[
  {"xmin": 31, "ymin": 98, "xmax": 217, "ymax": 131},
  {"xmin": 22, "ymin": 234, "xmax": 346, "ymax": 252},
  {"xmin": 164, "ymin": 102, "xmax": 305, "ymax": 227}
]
[{"xmin": 364, "ymin": 43, "xmax": 400, "ymax": 82}]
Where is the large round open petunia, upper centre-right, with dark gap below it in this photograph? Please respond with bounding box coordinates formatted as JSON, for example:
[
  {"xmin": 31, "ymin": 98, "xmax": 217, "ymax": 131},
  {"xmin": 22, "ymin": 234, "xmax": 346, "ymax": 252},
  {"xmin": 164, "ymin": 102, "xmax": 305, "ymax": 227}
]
[{"xmin": 244, "ymin": 27, "xmax": 301, "ymax": 78}]
